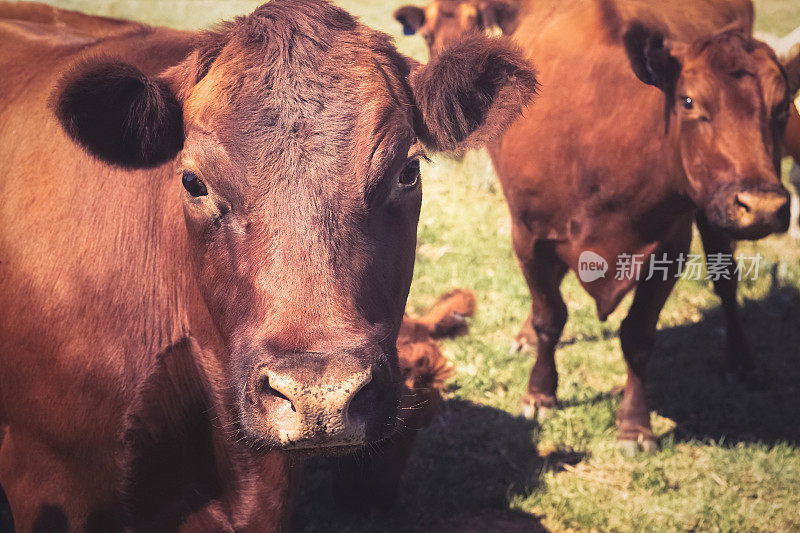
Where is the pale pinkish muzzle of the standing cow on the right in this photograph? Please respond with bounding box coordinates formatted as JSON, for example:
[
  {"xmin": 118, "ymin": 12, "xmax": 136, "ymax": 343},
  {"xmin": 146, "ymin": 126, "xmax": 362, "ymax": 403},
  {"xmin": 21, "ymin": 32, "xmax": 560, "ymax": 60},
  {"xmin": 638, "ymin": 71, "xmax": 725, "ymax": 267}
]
[{"xmin": 706, "ymin": 183, "xmax": 790, "ymax": 240}]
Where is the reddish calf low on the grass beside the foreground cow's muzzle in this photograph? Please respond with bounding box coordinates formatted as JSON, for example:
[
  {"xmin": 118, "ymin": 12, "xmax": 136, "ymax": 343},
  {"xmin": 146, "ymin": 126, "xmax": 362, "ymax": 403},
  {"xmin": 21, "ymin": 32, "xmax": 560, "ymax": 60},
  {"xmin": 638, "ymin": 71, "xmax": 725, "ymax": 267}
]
[{"xmin": 334, "ymin": 289, "xmax": 475, "ymax": 512}]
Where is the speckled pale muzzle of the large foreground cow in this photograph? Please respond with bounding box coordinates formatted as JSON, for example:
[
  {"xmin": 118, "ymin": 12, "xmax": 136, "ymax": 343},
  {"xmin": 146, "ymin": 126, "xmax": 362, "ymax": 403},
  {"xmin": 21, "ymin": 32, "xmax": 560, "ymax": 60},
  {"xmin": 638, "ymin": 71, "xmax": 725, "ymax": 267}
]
[{"xmin": 242, "ymin": 352, "xmax": 399, "ymax": 453}]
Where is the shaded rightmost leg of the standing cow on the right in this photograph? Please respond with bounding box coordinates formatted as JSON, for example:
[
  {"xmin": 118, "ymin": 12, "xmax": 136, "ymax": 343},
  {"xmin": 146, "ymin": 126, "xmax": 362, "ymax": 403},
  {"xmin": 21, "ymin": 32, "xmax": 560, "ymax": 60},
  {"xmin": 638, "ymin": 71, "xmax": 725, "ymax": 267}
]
[{"xmin": 697, "ymin": 214, "xmax": 754, "ymax": 381}]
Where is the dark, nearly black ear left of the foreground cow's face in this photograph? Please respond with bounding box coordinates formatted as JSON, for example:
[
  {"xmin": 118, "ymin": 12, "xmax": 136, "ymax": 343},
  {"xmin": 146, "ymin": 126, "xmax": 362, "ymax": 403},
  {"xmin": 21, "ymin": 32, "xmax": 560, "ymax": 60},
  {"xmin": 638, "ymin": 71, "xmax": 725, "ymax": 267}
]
[{"xmin": 53, "ymin": 59, "xmax": 184, "ymax": 168}]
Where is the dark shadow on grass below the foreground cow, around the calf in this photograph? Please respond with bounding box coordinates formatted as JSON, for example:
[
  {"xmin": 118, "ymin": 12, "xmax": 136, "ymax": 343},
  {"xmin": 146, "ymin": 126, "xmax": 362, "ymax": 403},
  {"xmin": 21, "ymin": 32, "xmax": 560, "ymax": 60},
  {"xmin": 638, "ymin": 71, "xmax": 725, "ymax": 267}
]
[{"xmin": 294, "ymin": 400, "xmax": 546, "ymax": 533}]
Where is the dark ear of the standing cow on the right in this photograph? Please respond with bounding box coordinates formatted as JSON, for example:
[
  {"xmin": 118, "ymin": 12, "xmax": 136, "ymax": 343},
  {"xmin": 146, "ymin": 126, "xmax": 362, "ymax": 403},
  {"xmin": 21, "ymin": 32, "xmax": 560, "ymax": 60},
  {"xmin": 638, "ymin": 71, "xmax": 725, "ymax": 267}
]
[{"xmin": 623, "ymin": 22, "xmax": 681, "ymax": 95}]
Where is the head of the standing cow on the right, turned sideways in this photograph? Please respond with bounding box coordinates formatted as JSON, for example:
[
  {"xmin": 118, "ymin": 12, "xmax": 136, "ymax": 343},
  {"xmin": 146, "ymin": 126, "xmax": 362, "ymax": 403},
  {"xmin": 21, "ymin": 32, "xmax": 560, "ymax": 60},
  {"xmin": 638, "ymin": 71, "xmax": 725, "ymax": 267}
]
[{"xmin": 624, "ymin": 23, "xmax": 790, "ymax": 239}]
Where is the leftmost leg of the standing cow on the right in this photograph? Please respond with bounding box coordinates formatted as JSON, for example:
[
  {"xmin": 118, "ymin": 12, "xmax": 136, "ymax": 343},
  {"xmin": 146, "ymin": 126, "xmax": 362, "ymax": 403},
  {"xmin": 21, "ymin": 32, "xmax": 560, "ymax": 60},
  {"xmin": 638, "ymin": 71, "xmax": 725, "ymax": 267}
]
[{"xmin": 514, "ymin": 228, "xmax": 567, "ymax": 418}]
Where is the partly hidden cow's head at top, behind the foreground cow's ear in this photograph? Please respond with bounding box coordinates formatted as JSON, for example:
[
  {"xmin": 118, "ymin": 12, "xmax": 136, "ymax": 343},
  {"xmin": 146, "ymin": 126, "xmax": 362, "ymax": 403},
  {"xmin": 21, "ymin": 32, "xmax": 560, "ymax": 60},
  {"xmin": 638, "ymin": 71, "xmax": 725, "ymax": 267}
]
[{"xmin": 394, "ymin": 0, "xmax": 518, "ymax": 58}]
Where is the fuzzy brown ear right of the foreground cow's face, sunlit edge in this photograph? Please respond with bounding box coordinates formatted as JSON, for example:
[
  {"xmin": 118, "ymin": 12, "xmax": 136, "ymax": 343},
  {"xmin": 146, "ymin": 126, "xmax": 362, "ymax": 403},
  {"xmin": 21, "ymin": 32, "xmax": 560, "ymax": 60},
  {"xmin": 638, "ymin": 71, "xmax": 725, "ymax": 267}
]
[{"xmin": 410, "ymin": 35, "xmax": 538, "ymax": 153}]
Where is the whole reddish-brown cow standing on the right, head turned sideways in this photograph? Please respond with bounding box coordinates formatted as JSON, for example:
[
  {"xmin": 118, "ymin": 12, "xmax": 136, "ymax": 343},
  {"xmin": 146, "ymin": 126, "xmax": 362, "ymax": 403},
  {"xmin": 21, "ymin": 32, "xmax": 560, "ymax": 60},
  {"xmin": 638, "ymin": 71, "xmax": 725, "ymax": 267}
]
[{"xmin": 396, "ymin": 0, "xmax": 790, "ymax": 452}]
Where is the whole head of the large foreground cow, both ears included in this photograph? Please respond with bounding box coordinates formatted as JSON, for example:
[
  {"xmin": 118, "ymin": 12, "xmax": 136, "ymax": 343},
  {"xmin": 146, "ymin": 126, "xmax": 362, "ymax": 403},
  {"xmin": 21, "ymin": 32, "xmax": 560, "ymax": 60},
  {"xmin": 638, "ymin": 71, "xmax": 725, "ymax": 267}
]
[{"xmin": 54, "ymin": 0, "xmax": 536, "ymax": 451}]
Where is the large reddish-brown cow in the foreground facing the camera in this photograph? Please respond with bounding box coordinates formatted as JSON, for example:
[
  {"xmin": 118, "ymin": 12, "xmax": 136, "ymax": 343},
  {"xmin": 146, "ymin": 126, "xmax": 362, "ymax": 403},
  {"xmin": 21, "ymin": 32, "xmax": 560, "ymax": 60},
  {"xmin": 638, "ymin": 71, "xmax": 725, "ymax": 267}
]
[{"xmin": 0, "ymin": 0, "xmax": 535, "ymax": 531}]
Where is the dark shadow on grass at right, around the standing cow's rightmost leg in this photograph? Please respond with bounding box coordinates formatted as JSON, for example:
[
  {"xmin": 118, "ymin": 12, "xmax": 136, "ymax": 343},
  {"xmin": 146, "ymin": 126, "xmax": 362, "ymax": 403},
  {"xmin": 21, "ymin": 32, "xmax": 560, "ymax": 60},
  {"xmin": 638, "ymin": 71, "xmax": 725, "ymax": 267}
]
[{"xmin": 647, "ymin": 286, "xmax": 800, "ymax": 445}]
